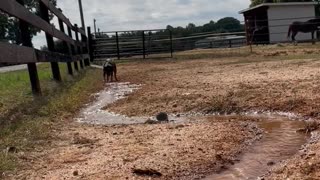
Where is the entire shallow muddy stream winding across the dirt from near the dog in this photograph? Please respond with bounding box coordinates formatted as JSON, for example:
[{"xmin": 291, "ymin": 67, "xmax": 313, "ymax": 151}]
[{"xmin": 77, "ymin": 83, "xmax": 308, "ymax": 180}]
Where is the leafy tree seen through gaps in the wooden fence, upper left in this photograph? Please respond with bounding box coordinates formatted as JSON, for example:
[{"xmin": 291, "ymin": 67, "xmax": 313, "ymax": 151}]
[{"xmin": 0, "ymin": 0, "xmax": 57, "ymax": 45}]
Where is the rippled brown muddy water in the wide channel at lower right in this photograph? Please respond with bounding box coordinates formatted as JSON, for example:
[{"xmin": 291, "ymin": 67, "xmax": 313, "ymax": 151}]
[{"xmin": 204, "ymin": 115, "xmax": 310, "ymax": 180}]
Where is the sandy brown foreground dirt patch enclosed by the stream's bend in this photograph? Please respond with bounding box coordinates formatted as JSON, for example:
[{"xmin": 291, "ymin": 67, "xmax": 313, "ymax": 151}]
[{"xmin": 12, "ymin": 116, "xmax": 258, "ymax": 179}]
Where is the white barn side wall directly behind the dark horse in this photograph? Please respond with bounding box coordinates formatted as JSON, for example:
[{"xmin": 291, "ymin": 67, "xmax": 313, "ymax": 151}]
[{"xmin": 268, "ymin": 5, "xmax": 315, "ymax": 43}]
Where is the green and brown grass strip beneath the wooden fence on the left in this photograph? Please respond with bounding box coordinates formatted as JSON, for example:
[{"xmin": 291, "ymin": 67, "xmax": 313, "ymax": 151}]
[{"xmin": 0, "ymin": 64, "xmax": 103, "ymax": 177}]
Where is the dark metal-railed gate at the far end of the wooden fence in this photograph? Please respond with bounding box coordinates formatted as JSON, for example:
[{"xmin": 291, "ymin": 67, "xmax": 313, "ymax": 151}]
[{"xmin": 92, "ymin": 29, "xmax": 173, "ymax": 60}]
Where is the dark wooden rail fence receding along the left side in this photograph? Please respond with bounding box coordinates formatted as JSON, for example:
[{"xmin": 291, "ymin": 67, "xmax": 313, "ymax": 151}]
[{"xmin": 0, "ymin": 0, "xmax": 90, "ymax": 95}]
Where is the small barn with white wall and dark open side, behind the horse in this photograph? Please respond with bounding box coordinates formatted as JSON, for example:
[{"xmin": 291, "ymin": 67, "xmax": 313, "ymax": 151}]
[{"xmin": 239, "ymin": 2, "xmax": 319, "ymax": 44}]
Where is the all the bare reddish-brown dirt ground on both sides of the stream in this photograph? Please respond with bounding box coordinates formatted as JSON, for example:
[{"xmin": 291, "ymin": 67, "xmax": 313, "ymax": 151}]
[{"xmin": 5, "ymin": 46, "xmax": 320, "ymax": 179}]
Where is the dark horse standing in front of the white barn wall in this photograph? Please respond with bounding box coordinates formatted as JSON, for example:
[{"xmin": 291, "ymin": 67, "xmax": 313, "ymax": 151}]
[{"xmin": 288, "ymin": 19, "xmax": 320, "ymax": 43}]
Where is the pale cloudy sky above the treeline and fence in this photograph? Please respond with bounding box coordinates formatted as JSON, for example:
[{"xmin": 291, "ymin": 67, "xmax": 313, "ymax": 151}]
[{"xmin": 33, "ymin": 0, "xmax": 250, "ymax": 48}]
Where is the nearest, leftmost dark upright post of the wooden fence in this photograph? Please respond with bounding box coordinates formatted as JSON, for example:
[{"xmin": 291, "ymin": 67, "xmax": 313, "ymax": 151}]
[{"xmin": 17, "ymin": 0, "xmax": 41, "ymax": 96}]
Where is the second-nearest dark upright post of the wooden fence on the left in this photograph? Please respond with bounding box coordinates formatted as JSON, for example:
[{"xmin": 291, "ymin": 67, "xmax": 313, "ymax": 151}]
[{"xmin": 39, "ymin": 1, "xmax": 61, "ymax": 81}]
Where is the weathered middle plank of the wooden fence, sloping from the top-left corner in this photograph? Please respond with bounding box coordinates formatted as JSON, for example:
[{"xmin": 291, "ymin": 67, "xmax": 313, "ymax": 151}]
[{"xmin": 0, "ymin": 0, "xmax": 75, "ymax": 44}]
